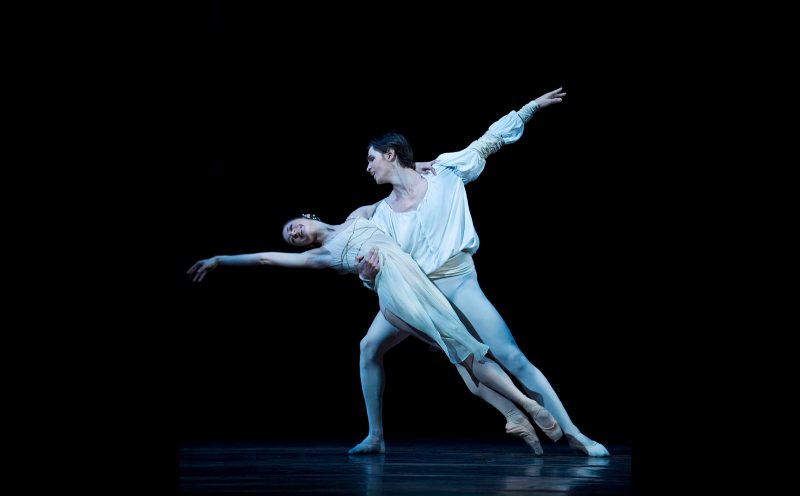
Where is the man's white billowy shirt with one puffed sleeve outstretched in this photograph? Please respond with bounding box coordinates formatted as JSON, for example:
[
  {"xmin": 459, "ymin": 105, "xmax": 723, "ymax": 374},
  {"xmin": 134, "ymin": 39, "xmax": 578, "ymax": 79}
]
[{"xmin": 372, "ymin": 108, "xmax": 536, "ymax": 274}]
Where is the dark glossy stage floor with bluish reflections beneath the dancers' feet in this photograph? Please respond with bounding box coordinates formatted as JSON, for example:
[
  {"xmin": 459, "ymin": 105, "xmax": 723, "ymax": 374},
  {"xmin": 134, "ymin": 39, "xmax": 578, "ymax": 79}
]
[{"xmin": 178, "ymin": 441, "xmax": 633, "ymax": 495}]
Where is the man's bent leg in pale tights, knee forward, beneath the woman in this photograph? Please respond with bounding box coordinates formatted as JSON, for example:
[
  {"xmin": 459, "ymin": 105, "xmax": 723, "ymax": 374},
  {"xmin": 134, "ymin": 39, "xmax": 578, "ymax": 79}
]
[{"xmin": 348, "ymin": 312, "xmax": 408, "ymax": 455}]
